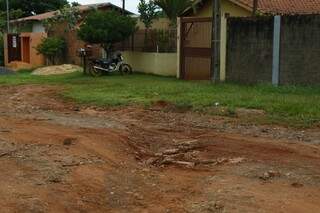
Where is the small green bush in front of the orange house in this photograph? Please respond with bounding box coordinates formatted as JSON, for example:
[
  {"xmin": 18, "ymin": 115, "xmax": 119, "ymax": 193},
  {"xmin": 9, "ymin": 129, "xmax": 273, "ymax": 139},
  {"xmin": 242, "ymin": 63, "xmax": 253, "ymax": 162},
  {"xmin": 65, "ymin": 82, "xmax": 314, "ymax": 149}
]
[{"xmin": 36, "ymin": 37, "xmax": 66, "ymax": 64}]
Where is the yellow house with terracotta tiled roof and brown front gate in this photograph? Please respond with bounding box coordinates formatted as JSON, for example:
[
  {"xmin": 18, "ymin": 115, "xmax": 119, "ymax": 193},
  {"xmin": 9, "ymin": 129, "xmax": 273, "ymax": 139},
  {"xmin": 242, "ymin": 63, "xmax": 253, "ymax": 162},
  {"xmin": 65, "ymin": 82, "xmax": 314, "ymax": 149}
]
[{"xmin": 177, "ymin": 0, "xmax": 320, "ymax": 81}]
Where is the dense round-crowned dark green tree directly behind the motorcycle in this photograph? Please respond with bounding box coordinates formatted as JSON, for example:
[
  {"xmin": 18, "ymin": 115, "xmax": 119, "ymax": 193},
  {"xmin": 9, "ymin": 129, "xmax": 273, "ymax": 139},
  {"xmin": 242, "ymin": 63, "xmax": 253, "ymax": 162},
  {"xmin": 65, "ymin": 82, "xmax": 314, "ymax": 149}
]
[{"xmin": 78, "ymin": 10, "xmax": 136, "ymax": 57}]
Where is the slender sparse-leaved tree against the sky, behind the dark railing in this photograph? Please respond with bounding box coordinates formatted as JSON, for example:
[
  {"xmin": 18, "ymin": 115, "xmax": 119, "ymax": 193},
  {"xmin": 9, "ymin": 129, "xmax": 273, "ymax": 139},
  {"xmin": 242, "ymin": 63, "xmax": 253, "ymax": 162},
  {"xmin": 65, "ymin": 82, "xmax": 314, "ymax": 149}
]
[{"xmin": 138, "ymin": 0, "xmax": 159, "ymax": 49}]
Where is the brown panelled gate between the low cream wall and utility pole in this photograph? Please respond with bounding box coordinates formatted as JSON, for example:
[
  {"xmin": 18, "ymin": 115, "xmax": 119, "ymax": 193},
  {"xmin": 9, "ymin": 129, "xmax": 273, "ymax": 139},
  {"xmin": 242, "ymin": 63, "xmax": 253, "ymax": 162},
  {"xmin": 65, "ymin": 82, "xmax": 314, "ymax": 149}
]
[{"xmin": 180, "ymin": 18, "xmax": 212, "ymax": 80}]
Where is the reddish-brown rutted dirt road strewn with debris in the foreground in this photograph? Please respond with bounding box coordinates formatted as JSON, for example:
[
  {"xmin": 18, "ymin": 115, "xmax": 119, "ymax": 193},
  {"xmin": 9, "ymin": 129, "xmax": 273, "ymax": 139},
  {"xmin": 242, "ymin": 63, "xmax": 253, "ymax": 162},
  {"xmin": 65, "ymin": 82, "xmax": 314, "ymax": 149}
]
[{"xmin": 0, "ymin": 86, "xmax": 320, "ymax": 213}]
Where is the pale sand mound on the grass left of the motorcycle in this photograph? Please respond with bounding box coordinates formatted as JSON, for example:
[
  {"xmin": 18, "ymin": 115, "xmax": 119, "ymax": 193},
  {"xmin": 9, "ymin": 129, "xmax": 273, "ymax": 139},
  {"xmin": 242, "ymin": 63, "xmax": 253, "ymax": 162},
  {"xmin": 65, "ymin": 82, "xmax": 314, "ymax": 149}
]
[{"xmin": 32, "ymin": 64, "xmax": 82, "ymax": 75}]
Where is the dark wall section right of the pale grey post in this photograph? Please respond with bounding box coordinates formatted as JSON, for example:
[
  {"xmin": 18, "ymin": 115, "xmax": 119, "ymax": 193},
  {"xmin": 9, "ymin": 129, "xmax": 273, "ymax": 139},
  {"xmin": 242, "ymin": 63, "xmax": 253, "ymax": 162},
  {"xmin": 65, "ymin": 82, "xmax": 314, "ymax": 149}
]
[{"xmin": 280, "ymin": 15, "xmax": 320, "ymax": 85}]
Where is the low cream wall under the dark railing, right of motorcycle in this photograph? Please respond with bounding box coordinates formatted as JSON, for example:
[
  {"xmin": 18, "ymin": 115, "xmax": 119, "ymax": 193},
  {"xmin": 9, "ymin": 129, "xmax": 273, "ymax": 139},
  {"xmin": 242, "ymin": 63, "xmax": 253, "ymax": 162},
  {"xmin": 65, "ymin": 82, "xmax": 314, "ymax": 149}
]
[{"xmin": 123, "ymin": 51, "xmax": 177, "ymax": 76}]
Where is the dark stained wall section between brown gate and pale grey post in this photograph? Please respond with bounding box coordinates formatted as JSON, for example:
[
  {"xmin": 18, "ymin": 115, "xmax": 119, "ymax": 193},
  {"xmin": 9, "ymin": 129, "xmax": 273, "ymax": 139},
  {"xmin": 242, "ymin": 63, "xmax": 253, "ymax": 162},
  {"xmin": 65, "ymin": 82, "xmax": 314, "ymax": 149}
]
[{"xmin": 226, "ymin": 17, "xmax": 273, "ymax": 84}]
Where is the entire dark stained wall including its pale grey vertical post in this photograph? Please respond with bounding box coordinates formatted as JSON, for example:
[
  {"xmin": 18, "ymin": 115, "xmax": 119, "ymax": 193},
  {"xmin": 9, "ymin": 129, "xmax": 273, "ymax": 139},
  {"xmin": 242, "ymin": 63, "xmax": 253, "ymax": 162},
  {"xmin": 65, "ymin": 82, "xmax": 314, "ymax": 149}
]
[{"xmin": 226, "ymin": 15, "xmax": 320, "ymax": 84}]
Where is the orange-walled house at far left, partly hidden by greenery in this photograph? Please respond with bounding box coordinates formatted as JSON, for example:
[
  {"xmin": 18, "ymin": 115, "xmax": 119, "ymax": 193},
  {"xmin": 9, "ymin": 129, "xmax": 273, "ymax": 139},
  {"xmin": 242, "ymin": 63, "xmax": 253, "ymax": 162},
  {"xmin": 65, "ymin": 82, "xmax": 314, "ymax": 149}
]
[{"xmin": 4, "ymin": 3, "xmax": 132, "ymax": 69}]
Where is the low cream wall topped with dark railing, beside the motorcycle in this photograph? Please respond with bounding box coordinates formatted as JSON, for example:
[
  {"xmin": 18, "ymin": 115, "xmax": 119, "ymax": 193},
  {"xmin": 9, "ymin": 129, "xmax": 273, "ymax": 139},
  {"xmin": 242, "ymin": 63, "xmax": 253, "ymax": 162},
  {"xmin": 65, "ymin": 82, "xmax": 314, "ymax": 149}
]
[{"xmin": 115, "ymin": 29, "xmax": 177, "ymax": 76}]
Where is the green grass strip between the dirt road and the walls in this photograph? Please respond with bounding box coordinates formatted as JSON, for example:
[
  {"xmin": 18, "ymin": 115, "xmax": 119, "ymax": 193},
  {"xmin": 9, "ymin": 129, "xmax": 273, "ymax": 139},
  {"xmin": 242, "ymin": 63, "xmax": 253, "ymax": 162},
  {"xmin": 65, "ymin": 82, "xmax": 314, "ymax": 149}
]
[{"xmin": 0, "ymin": 72, "xmax": 320, "ymax": 126}]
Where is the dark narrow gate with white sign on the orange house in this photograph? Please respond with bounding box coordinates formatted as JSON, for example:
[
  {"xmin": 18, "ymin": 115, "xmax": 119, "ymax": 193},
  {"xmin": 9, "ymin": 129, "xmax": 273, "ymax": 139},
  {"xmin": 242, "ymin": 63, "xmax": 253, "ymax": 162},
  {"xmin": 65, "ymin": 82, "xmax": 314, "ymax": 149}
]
[{"xmin": 7, "ymin": 34, "xmax": 21, "ymax": 63}]
